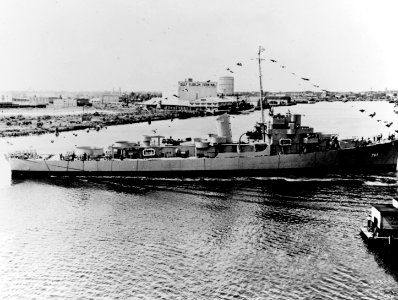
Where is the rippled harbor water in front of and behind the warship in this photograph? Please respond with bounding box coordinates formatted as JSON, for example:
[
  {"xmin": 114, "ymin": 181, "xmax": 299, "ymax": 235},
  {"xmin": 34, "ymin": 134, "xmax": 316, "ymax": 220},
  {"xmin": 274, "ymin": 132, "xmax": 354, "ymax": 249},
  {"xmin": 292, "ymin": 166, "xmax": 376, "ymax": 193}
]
[{"xmin": 0, "ymin": 102, "xmax": 398, "ymax": 299}]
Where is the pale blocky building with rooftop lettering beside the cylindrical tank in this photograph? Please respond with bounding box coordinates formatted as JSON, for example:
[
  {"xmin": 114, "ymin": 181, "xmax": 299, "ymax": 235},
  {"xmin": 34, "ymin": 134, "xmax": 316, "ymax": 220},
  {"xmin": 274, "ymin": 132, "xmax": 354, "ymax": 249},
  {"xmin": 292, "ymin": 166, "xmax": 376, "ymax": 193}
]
[{"xmin": 178, "ymin": 78, "xmax": 217, "ymax": 101}]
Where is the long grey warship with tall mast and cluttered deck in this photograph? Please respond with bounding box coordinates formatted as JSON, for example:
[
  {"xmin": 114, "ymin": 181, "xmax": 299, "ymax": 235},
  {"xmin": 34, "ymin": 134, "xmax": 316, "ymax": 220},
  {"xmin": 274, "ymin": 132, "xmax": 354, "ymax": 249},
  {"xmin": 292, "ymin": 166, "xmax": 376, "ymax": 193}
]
[{"xmin": 7, "ymin": 47, "xmax": 398, "ymax": 177}]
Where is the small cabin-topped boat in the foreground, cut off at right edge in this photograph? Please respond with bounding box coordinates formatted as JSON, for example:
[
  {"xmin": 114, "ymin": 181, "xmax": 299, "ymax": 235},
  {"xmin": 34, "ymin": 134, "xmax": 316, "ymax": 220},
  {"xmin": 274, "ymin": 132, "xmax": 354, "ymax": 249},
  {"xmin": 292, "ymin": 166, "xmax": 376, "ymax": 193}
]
[{"xmin": 361, "ymin": 199, "xmax": 398, "ymax": 246}]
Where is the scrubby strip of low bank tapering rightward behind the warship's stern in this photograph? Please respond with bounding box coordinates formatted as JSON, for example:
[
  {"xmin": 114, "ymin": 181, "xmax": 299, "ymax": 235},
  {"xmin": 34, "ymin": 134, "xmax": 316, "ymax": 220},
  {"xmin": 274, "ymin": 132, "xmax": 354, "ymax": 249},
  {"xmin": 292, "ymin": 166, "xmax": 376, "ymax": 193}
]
[{"xmin": 0, "ymin": 110, "xmax": 204, "ymax": 138}]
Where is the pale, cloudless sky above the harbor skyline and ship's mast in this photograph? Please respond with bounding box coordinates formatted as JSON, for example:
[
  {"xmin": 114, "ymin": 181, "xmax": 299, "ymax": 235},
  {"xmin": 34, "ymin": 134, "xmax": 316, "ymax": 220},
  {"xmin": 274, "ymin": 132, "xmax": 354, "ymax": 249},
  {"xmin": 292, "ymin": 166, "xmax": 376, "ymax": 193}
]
[{"xmin": 0, "ymin": 0, "xmax": 398, "ymax": 94}]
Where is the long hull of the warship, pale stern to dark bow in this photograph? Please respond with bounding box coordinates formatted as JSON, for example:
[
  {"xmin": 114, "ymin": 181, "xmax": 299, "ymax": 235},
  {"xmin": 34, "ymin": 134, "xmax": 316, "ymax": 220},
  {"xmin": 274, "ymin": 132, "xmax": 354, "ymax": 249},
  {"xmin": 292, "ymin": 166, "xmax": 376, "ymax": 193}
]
[{"xmin": 9, "ymin": 141, "xmax": 398, "ymax": 177}]
